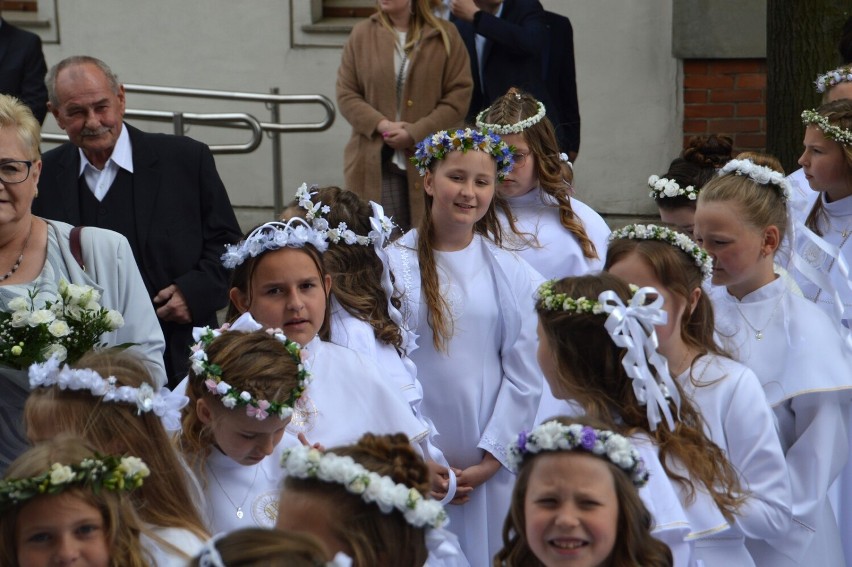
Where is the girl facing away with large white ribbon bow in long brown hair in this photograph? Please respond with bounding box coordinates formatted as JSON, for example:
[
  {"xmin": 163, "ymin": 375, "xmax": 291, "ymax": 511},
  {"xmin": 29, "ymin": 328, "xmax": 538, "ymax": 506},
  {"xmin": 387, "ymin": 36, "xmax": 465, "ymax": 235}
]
[{"xmin": 536, "ymin": 272, "xmax": 751, "ymax": 566}]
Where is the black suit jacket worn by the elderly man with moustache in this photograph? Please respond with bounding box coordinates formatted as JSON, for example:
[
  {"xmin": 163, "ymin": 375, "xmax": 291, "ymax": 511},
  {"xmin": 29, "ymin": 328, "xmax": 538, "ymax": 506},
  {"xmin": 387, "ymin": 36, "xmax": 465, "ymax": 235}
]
[{"xmin": 33, "ymin": 123, "xmax": 242, "ymax": 380}]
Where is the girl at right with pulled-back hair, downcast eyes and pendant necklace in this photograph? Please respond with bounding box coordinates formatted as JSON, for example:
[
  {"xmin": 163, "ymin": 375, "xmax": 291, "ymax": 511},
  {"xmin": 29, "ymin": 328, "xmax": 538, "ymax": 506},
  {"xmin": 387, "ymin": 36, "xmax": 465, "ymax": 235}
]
[{"xmin": 695, "ymin": 157, "xmax": 852, "ymax": 565}]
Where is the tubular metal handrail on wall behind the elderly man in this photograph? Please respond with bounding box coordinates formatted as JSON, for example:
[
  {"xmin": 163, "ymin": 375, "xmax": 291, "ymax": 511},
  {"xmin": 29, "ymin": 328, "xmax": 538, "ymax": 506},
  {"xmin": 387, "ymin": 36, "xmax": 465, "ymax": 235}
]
[{"xmin": 42, "ymin": 84, "xmax": 337, "ymax": 217}]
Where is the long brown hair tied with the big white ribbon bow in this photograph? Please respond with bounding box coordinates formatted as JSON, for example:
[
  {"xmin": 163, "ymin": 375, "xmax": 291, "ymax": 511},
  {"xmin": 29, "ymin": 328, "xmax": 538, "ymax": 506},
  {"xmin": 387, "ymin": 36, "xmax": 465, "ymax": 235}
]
[{"xmin": 536, "ymin": 272, "xmax": 743, "ymax": 520}]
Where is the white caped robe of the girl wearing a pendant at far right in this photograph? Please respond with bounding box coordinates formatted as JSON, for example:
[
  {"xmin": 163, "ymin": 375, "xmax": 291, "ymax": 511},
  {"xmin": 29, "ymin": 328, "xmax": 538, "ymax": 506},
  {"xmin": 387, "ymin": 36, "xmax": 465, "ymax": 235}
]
[{"xmin": 710, "ymin": 278, "xmax": 852, "ymax": 566}]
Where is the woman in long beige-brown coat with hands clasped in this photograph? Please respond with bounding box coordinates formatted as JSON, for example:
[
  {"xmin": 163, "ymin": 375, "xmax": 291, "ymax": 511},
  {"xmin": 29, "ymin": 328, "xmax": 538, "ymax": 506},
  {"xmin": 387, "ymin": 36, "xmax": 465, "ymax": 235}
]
[{"xmin": 337, "ymin": 0, "xmax": 473, "ymax": 230}]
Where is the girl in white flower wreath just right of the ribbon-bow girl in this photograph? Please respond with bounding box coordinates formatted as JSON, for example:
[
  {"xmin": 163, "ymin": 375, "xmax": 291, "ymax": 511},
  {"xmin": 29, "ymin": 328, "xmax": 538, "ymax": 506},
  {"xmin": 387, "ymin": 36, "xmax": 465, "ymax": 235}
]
[{"xmin": 605, "ymin": 225, "xmax": 792, "ymax": 565}]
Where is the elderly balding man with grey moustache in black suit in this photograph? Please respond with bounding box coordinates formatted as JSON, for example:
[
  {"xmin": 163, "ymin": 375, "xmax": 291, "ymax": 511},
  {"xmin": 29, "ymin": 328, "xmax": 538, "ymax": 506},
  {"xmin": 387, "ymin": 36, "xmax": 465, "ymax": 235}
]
[{"xmin": 33, "ymin": 56, "xmax": 241, "ymax": 383}]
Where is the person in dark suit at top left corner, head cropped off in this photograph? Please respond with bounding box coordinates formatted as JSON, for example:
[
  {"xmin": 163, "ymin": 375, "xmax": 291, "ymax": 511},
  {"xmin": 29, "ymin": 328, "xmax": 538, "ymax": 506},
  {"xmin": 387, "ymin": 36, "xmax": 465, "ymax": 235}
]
[{"xmin": 0, "ymin": 18, "xmax": 47, "ymax": 124}]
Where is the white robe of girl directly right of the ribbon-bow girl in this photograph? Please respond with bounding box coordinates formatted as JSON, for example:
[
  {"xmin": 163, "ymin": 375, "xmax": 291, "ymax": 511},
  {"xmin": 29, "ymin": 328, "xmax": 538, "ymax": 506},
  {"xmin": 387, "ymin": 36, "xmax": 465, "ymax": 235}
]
[{"xmin": 677, "ymin": 354, "xmax": 792, "ymax": 567}]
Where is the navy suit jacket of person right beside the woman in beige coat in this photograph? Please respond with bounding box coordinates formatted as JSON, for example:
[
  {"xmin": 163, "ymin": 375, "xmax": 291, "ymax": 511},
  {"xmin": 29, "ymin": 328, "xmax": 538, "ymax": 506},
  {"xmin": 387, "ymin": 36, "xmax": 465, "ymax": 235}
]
[{"xmin": 451, "ymin": 0, "xmax": 555, "ymax": 123}]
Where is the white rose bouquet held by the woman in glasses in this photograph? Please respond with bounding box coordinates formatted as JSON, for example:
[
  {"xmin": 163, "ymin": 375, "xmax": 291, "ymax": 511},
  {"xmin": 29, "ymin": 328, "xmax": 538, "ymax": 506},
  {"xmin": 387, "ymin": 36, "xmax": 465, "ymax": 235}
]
[{"xmin": 0, "ymin": 279, "xmax": 125, "ymax": 369}]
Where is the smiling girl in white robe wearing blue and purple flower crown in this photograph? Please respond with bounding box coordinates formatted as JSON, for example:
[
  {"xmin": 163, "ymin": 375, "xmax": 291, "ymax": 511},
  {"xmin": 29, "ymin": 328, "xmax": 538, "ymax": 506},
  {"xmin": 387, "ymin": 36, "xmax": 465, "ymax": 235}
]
[{"xmin": 388, "ymin": 129, "xmax": 542, "ymax": 565}]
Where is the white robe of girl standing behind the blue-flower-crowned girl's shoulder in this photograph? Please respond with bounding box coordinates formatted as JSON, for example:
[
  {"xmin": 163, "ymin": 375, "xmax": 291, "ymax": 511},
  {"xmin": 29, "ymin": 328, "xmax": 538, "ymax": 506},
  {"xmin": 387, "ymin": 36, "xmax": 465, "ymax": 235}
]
[{"xmin": 498, "ymin": 187, "xmax": 610, "ymax": 279}]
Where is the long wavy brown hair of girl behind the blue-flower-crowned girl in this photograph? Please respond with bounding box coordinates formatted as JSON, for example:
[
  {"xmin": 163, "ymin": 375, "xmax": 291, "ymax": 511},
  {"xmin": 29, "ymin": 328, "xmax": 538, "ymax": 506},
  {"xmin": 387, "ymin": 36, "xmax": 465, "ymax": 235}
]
[{"xmin": 485, "ymin": 87, "xmax": 600, "ymax": 258}]
